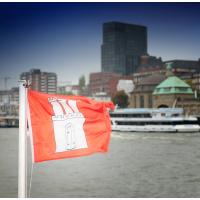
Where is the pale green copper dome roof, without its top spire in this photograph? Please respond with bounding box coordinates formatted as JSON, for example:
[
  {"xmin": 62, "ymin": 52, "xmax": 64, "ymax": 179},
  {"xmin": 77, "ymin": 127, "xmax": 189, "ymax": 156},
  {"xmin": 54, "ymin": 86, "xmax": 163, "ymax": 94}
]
[{"xmin": 153, "ymin": 76, "xmax": 193, "ymax": 95}]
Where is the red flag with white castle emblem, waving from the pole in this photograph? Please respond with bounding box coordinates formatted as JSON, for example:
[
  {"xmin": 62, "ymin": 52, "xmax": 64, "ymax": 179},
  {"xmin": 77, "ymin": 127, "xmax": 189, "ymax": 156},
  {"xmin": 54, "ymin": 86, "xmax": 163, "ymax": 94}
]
[{"xmin": 28, "ymin": 90, "xmax": 114, "ymax": 162}]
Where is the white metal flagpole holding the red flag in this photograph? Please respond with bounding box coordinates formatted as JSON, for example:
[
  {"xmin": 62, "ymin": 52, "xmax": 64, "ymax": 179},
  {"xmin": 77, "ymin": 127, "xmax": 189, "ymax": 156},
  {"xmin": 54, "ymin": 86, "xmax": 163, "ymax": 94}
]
[{"xmin": 18, "ymin": 80, "xmax": 27, "ymax": 198}]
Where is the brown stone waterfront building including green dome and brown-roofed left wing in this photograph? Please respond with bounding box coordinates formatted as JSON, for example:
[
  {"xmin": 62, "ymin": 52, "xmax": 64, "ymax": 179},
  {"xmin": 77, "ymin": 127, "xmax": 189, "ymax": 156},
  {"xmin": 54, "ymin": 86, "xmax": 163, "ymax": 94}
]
[{"xmin": 129, "ymin": 64, "xmax": 200, "ymax": 116}]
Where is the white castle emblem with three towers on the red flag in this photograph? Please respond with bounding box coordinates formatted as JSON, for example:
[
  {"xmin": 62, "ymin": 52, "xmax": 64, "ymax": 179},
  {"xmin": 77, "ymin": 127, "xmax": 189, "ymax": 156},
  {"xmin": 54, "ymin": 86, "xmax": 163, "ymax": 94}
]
[{"xmin": 48, "ymin": 97, "xmax": 88, "ymax": 152}]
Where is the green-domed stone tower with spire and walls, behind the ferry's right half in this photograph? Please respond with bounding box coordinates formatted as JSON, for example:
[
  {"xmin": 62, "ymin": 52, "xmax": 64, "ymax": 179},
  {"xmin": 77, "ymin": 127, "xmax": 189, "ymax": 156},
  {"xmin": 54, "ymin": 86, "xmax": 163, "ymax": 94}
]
[{"xmin": 153, "ymin": 65, "xmax": 200, "ymax": 116}]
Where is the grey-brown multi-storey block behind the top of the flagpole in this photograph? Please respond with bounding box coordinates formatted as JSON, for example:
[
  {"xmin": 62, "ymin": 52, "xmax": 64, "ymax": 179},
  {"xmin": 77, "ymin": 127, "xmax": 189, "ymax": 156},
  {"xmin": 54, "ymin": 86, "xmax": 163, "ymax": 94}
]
[{"xmin": 20, "ymin": 69, "xmax": 57, "ymax": 94}]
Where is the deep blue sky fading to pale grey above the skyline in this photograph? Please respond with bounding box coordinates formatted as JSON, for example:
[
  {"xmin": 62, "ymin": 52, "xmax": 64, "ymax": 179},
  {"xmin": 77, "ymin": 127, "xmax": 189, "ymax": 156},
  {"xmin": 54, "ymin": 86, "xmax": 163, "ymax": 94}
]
[{"xmin": 0, "ymin": 2, "xmax": 200, "ymax": 90}]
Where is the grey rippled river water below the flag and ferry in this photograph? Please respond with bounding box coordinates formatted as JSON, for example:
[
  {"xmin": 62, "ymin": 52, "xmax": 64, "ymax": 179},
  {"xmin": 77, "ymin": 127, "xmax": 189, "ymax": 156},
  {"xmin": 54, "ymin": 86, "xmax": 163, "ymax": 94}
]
[{"xmin": 0, "ymin": 129, "xmax": 200, "ymax": 198}]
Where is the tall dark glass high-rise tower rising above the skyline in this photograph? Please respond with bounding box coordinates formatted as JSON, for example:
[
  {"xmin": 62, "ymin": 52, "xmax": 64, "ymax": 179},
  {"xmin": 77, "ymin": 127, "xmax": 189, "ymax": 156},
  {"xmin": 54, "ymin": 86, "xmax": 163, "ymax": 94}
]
[{"xmin": 101, "ymin": 22, "xmax": 147, "ymax": 75}]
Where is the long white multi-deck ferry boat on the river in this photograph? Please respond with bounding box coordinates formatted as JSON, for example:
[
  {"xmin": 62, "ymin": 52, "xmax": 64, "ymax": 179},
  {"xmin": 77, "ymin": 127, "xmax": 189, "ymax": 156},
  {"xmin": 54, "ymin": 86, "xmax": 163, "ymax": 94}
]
[{"xmin": 110, "ymin": 108, "xmax": 200, "ymax": 132}]
